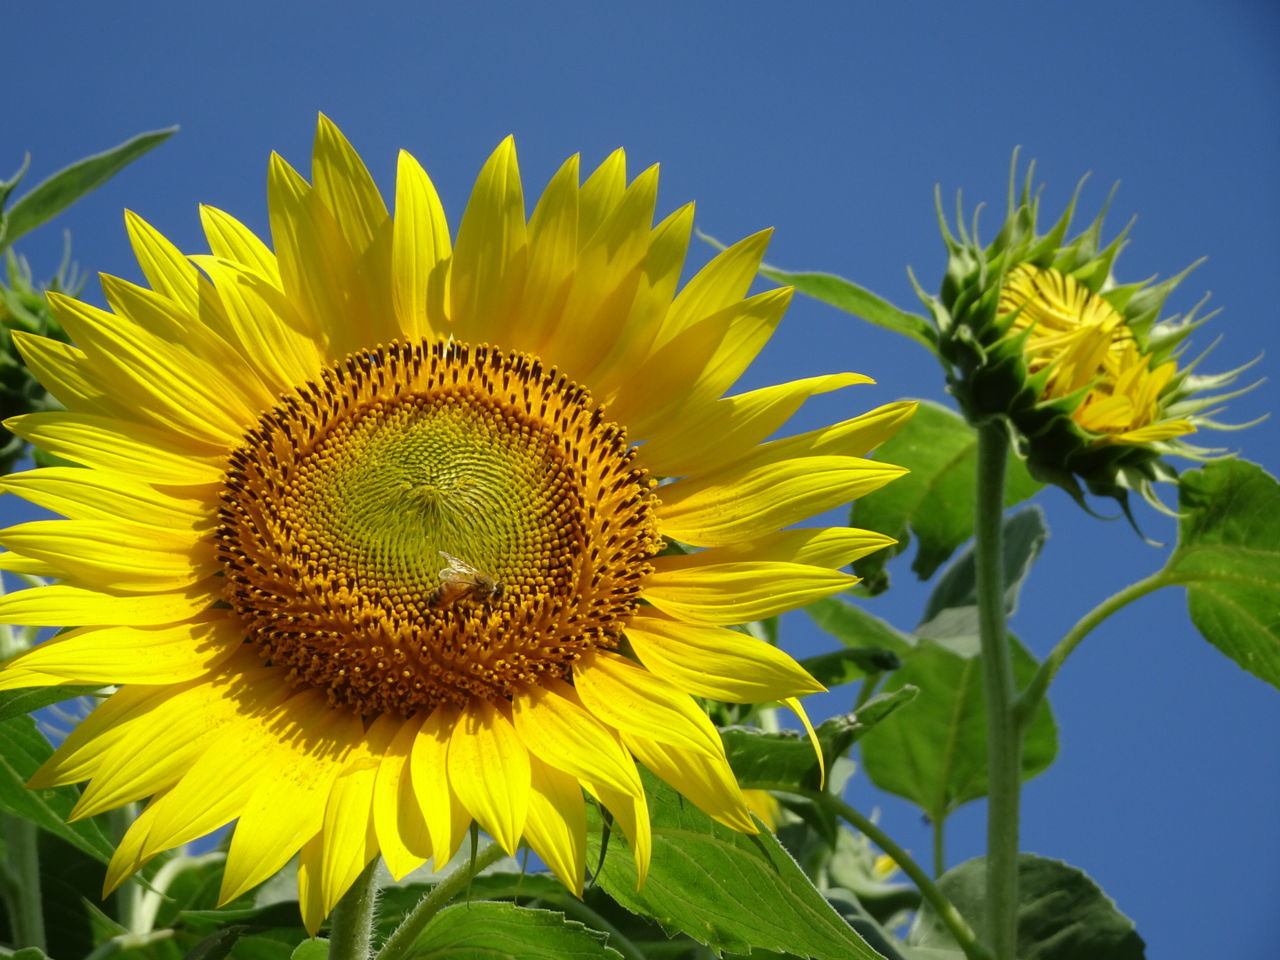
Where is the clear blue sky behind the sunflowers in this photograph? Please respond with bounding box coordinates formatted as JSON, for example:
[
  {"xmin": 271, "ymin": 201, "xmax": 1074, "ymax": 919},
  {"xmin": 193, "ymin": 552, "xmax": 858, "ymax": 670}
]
[{"xmin": 0, "ymin": 0, "xmax": 1280, "ymax": 960}]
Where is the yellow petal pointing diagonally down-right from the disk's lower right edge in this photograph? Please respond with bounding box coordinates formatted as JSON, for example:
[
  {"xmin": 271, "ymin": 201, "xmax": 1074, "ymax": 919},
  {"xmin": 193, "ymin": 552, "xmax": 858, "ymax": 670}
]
[{"xmin": 573, "ymin": 652, "xmax": 724, "ymax": 768}]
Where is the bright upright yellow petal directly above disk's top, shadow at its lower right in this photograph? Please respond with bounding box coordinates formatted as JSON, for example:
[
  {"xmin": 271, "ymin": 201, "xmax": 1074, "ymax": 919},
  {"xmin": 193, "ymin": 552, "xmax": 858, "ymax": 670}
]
[{"xmin": 392, "ymin": 150, "xmax": 452, "ymax": 339}]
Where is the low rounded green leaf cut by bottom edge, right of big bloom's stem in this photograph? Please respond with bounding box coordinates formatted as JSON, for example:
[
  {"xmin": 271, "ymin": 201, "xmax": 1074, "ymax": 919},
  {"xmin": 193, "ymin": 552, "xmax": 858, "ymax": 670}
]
[{"xmin": 410, "ymin": 901, "xmax": 622, "ymax": 960}]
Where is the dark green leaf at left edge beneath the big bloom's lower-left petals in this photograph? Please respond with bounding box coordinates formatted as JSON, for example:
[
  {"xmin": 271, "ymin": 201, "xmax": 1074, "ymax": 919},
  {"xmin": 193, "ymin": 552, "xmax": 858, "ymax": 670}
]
[{"xmin": 0, "ymin": 716, "xmax": 111, "ymax": 863}]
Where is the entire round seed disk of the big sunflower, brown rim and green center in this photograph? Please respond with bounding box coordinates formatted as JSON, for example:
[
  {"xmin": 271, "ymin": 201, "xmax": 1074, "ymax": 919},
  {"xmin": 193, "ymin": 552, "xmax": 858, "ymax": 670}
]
[{"xmin": 216, "ymin": 342, "xmax": 660, "ymax": 716}]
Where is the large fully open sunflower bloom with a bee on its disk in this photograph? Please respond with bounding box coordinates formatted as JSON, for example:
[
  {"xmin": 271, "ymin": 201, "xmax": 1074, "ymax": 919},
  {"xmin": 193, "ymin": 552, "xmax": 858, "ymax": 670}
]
[{"xmin": 0, "ymin": 118, "xmax": 911, "ymax": 931}]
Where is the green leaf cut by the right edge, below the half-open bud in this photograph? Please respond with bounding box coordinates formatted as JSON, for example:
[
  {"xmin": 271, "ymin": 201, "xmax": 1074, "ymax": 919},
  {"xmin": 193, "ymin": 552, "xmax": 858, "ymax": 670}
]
[{"xmin": 1164, "ymin": 460, "xmax": 1280, "ymax": 687}]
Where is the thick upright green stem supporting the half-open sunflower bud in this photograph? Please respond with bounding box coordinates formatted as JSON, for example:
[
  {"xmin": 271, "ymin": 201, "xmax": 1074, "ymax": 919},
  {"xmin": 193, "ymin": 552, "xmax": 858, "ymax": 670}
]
[{"xmin": 974, "ymin": 422, "xmax": 1021, "ymax": 960}]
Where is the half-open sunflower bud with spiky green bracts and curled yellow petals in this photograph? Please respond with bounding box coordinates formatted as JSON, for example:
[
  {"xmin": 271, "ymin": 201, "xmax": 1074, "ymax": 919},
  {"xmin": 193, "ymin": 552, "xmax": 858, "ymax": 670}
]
[{"xmin": 918, "ymin": 155, "xmax": 1244, "ymax": 513}]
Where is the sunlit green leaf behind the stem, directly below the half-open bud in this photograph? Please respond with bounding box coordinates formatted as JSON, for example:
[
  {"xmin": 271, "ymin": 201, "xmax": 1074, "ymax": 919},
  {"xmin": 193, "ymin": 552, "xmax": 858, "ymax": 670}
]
[{"xmin": 850, "ymin": 401, "xmax": 1041, "ymax": 596}]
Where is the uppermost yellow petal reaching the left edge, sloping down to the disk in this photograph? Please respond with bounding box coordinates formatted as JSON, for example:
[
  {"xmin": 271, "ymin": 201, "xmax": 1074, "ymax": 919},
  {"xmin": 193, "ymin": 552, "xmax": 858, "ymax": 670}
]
[{"xmin": 4, "ymin": 412, "xmax": 223, "ymax": 486}]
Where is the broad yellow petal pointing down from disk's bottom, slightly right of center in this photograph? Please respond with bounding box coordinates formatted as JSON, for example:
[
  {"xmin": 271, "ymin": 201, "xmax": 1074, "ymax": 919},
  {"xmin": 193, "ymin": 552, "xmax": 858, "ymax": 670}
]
[{"xmin": 449, "ymin": 700, "xmax": 530, "ymax": 856}]
